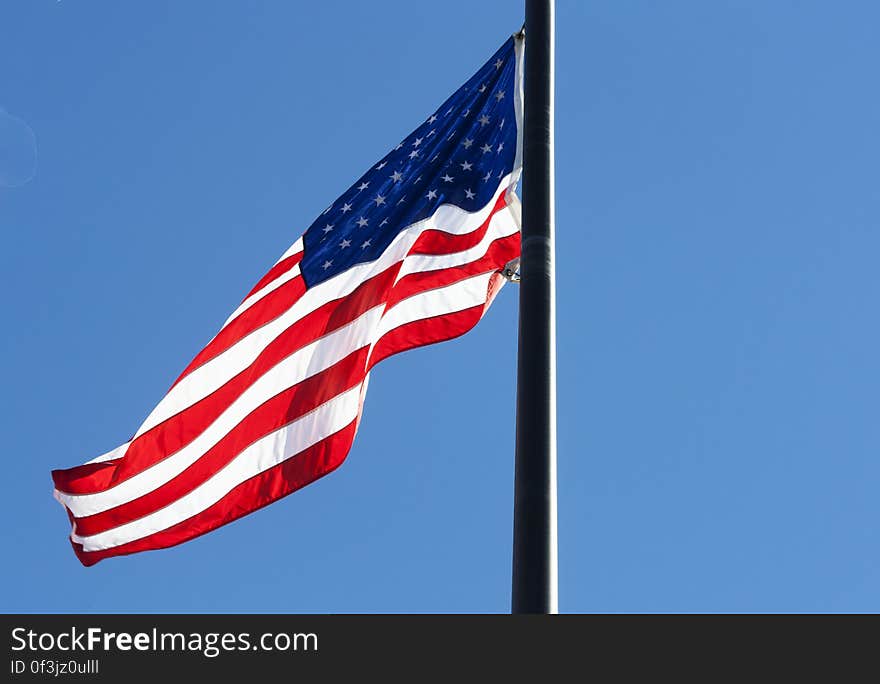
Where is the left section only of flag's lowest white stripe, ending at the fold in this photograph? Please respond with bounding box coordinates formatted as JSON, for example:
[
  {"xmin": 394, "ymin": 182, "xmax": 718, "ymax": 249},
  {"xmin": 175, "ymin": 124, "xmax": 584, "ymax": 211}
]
[{"xmin": 70, "ymin": 385, "xmax": 360, "ymax": 551}]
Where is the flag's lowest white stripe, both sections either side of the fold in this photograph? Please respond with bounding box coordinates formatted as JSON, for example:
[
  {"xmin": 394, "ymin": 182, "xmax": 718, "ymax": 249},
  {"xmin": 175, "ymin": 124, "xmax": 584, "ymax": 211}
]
[{"xmin": 71, "ymin": 271, "xmax": 502, "ymax": 551}]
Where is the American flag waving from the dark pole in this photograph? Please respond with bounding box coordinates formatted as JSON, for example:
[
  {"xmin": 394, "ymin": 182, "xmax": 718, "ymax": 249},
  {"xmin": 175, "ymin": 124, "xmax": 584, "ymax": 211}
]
[{"xmin": 52, "ymin": 37, "xmax": 523, "ymax": 565}]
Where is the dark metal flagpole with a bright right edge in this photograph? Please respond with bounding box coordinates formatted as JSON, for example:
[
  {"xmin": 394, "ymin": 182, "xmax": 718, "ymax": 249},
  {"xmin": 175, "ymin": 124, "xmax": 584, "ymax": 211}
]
[{"xmin": 512, "ymin": 0, "xmax": 558, "ymax": 613}]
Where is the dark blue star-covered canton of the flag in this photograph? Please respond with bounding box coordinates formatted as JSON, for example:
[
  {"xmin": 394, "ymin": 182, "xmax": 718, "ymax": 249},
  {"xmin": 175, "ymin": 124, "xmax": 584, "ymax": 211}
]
[{"xmin": 300, "ymin": 38, "xmax": 516, "ymax": 287}]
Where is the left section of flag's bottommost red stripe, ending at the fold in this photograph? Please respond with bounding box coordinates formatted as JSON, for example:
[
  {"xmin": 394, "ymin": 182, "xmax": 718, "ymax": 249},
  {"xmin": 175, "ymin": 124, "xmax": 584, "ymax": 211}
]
[{"xmin": 71, "ymin": 421, "xmax": 356, "ymax": 566}]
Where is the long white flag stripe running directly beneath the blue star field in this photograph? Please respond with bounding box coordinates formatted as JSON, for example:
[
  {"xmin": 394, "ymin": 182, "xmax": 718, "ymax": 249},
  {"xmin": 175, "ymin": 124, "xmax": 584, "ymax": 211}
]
[{"xmin": 135, "ymin": 177, "xmax": 508, "ymax": 437}]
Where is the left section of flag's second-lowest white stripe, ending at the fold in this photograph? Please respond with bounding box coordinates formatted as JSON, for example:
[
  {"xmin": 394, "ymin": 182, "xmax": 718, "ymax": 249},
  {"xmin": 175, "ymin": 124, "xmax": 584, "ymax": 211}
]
[{"xmin": 56, "ymin": 304, "xmax": 383, "ymax": 518}]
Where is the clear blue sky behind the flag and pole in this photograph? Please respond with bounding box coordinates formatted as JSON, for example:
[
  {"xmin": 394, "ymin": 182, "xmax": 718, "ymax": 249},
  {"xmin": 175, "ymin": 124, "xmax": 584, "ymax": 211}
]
[{"xmin": 0, "ymin": 0, "xmax": 880, "ymax": 612}]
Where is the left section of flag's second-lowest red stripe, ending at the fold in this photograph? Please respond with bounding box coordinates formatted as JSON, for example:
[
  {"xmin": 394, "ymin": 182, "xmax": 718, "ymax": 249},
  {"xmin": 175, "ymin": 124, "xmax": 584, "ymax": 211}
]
[{"xmin": 76, "ymin": 347, "xmax": 369, "ymax": 536}]
